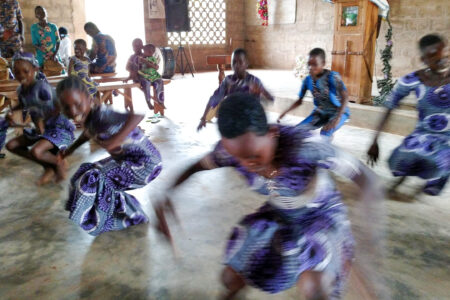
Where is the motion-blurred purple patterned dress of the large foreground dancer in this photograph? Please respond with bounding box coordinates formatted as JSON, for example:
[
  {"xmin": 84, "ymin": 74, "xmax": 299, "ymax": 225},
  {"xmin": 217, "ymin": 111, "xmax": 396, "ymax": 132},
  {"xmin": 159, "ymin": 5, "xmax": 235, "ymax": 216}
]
[{"xmin": 202, "ymin": 126, "xmax": 360, "ymax": 298}]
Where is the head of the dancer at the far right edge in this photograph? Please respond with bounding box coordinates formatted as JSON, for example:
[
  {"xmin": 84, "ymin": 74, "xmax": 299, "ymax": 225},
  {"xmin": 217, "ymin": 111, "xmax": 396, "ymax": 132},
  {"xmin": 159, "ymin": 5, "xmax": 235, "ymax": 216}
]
[{"xmin": 419, "ymin": 34, "xmax": 448, "ymax": 71}]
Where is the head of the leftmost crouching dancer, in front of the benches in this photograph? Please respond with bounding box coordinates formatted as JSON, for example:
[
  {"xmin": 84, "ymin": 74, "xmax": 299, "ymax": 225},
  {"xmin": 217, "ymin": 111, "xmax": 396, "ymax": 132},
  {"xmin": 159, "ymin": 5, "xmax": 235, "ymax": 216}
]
[{"xmin": 13, "ymin": 52, "xmax": 39, "ymax": 86}]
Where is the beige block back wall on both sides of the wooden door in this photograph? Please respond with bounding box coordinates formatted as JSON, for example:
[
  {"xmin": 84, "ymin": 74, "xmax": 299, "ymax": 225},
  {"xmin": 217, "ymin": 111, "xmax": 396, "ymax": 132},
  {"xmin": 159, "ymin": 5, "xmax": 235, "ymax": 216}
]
[{"xmin": 245, "ymin": 0, "xmax": 450, "ymax": 76}]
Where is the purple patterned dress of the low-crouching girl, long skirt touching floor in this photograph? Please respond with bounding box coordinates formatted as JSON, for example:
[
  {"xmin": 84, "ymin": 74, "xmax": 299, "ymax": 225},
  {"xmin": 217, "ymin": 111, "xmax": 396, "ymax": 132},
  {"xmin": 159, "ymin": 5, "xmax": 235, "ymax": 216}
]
[{"xmin": 66, "ymin": 105, "xmax": 162, "ymax": 236}]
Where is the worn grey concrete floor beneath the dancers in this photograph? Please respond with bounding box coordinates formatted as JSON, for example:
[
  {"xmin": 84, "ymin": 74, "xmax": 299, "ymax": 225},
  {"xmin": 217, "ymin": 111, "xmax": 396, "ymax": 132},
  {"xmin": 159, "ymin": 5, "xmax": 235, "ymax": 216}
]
[{"xmin": 0, "ymin": 73, "xmax": 450, "ymax": 300}]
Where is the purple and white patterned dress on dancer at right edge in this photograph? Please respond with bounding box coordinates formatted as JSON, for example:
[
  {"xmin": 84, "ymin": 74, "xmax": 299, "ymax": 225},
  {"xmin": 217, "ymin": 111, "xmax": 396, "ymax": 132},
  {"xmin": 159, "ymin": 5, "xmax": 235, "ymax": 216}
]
[{"xmin": 385, "ymin": 72, "xmax": 450, "ymax": 195}]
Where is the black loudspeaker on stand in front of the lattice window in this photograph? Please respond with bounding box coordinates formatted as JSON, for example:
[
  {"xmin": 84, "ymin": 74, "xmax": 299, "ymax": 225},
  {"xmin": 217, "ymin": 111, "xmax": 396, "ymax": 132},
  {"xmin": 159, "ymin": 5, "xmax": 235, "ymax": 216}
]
[{"xmin": 165, "ymin": 0, "xmax": 191, "ymax": 32}]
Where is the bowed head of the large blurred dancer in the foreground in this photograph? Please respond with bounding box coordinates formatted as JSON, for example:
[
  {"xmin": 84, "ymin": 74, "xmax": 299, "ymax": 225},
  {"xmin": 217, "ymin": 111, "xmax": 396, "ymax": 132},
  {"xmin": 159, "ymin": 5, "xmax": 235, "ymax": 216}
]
[{"xmin": 218, "ymin": 93, "xmax": 278, "ymax": 172}]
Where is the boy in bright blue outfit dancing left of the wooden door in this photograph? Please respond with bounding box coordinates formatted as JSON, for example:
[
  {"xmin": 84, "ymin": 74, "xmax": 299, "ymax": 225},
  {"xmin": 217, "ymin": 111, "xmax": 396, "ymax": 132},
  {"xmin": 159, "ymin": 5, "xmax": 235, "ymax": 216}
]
[{"xmin": 278, "ymin": 48, "xmax": 350, "ymax": 137}]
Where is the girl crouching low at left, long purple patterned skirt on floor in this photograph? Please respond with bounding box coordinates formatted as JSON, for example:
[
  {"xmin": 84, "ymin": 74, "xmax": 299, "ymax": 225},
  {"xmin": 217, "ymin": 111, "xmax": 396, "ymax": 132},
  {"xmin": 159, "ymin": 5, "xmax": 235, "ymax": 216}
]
[{"xmin": 57, "ymin": 76, "xmax": 162, "ymax": 235}]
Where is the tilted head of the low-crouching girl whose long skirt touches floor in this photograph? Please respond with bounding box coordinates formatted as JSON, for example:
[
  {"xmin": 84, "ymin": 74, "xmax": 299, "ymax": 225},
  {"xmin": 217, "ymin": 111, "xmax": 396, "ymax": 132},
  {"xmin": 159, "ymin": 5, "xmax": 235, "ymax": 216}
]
[{"xmin": 56, "ymin": 76, "xmax": 91, "ymax": 123}]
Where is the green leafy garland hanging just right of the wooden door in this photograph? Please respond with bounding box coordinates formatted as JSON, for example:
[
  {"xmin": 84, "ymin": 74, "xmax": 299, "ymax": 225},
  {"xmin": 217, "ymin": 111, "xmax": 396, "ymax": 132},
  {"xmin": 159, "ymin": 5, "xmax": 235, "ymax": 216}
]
[{"xmin": 373, "ymin": 16, "xmax": 395, "ymax": 105}]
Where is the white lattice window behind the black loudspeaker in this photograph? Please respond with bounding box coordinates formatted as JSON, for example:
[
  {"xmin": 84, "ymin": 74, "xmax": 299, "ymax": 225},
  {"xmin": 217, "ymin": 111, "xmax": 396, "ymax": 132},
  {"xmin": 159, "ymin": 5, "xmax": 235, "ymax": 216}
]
[{"xmin": 167, "ymin": 0, "xmax": 226, "ymax": 45}]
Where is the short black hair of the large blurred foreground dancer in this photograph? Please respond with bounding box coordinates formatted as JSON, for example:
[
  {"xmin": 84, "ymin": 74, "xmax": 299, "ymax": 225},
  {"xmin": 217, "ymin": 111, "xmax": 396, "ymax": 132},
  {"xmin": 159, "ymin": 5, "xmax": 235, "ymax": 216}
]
[{"xmin": 218, "ymin": 93, "xmax": 269, "ymax": 139}]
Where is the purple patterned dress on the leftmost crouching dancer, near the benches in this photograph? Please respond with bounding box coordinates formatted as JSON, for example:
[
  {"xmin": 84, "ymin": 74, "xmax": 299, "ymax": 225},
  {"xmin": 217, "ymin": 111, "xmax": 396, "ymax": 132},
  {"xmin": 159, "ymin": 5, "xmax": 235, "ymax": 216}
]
[{"xmin": 17, "ymin": 80, "xmax": 75, "ymax": 150}]
